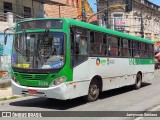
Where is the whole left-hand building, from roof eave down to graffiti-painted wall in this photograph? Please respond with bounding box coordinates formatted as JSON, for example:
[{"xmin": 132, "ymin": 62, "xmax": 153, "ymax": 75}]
[{"xmin": 0, "ymin": 0, "xmax": 61, "ymax": 83}]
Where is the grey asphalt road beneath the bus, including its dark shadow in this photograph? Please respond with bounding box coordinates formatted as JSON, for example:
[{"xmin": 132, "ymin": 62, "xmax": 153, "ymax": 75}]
[{"xmin": 0, "ymin": 70, "xmax": 160, "ymax": 120}]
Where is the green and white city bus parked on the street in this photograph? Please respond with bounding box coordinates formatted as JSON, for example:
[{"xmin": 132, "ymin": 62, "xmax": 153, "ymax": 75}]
[{"xmin": 5, "ymin": 18, "xmax": 154, "ymax": 102}]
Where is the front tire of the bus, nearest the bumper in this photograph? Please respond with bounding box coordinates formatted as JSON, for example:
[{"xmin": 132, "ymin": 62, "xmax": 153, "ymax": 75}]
[{"xmin": 84, "ymin": 80, "xmax": 100, "ymax": 102}]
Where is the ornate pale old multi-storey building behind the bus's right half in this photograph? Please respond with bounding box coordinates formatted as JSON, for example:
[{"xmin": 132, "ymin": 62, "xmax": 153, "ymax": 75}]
[{"xmin": 97, "ymin": 0, "xmax": 160, "ymax": 42}]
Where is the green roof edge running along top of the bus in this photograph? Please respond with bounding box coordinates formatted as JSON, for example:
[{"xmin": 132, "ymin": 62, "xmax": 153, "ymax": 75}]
[{"xmin": 17, "ymin": 18, "xmax": 154, "ymax": 44}]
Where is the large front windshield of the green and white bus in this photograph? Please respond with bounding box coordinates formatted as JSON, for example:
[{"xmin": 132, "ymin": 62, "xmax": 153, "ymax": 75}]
[{"xmin": 12, "ymin": 30, "xmax": 65, "ymax": 69}]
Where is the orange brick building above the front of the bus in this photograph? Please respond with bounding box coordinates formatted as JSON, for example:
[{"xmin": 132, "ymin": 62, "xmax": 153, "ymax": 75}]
[{"xmin": 44, "ymin": 0, "xmax": 97, "ymax": 22}]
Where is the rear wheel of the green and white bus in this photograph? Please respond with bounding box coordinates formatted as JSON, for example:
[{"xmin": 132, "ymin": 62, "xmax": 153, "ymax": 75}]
[{"xmin": 134, "ymin": 73, "xmax": 142, "ymax": 90}]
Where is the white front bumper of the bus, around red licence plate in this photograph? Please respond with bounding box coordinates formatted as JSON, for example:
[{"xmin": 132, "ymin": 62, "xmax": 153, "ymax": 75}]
[{"xmin": 11, "ymin": 80, "xmax": 68, "ymax": 100}]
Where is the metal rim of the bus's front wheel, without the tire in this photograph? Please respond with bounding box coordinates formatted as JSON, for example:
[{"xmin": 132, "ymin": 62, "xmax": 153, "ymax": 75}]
[{"xmin": 89, "ymin": 84, "xmax": 99, "ymax": 99}]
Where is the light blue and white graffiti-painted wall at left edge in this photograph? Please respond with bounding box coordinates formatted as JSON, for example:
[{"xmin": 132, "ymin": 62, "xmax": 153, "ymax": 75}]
[{"xmin": 0, "ymin": 33, "xmax": 13, "ymax": 81}]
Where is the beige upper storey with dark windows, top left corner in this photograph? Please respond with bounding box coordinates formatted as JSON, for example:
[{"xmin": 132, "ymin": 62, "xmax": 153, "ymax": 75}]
[{"xmin": 0, "ymin": 0, "xmax": 44, "ymax": 18}]
